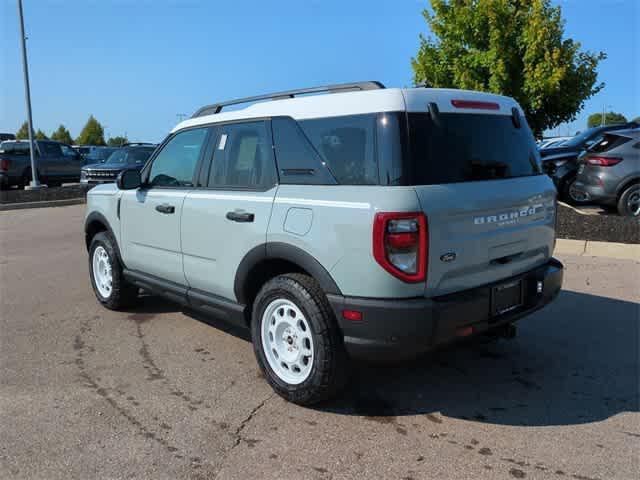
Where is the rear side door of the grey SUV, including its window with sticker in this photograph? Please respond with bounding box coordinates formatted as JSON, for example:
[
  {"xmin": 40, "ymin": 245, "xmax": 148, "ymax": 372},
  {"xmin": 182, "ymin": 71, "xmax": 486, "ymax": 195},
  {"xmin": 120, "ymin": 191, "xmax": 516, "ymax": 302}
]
[{"xmin": 182, "ymin": 120, "xmax": 277, "ymax": 300}]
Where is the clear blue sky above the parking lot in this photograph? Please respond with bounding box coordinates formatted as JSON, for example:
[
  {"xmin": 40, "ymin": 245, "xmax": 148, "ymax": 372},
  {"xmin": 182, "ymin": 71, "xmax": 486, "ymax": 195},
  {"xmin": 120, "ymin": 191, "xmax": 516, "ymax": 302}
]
[{"xmin": 0, "ymin": 0, "xmax": 640, "ymax": 142}]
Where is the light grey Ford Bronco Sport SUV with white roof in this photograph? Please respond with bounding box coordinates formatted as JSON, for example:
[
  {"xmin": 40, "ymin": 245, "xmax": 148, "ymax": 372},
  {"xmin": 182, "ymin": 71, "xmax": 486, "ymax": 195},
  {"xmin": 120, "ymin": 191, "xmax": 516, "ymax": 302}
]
[{"xmin": 85, "ymin": 82, "xmax": 563, "ymax": 404}]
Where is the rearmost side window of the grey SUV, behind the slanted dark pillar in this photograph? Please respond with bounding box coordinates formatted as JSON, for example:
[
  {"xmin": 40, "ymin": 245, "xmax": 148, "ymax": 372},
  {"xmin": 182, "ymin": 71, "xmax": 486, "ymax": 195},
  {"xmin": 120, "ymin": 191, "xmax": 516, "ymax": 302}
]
[{"xmin": 298, "ymin": 114, "xmax": 378, "ymax": 185}]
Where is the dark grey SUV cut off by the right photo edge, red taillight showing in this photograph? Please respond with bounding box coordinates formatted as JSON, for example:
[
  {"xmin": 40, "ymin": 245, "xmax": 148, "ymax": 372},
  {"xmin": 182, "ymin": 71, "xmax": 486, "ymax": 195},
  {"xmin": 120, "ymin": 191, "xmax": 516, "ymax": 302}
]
[{"xmin": 569, "ymin": 128, "xmax": 640, "ymax": 217}]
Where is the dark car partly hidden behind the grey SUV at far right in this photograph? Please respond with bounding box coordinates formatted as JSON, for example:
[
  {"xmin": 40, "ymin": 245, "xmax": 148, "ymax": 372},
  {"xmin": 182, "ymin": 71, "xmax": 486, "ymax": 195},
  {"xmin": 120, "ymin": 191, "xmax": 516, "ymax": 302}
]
[{"xmin": 540, "ymin": 122, "xmax": 639, "ymax": 201}]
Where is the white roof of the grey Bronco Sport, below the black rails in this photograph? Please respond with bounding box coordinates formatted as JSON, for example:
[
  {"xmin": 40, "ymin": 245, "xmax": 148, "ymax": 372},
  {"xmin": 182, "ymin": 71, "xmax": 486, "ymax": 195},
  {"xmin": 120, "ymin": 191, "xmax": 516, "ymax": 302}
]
[{"xmin": 171, "ymin": 88, "xmax": 524, "ymax": 133}]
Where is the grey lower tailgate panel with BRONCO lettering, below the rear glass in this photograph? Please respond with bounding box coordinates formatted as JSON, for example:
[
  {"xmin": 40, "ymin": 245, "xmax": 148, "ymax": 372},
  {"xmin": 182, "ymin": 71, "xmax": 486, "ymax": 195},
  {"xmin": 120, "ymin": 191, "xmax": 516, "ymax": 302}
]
[{"xmin": 415, "ymin": 175, "xmax": 556, "ymax": 297}]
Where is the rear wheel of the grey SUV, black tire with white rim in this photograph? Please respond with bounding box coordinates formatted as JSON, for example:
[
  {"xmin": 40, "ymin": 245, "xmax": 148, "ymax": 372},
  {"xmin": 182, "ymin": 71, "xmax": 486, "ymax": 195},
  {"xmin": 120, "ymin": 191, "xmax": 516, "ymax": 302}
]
[{"xmin": 251, "ymin": 273, "xmax": 348, "ymax": 405}]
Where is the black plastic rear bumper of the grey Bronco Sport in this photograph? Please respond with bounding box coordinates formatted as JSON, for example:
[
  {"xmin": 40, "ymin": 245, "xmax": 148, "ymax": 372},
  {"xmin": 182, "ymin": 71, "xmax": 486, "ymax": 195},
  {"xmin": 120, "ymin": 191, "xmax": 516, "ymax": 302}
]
[{"xmin": 328, "ymin": 259, "xmax": 564, "ymax": 362}]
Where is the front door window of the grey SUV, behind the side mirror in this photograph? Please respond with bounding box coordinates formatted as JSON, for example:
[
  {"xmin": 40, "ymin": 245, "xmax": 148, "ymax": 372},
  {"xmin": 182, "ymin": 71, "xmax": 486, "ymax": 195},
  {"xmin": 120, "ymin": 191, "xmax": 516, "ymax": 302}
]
[{"xmin": 149, "ymin": 128, "xmax": 208, "ymax": 187}]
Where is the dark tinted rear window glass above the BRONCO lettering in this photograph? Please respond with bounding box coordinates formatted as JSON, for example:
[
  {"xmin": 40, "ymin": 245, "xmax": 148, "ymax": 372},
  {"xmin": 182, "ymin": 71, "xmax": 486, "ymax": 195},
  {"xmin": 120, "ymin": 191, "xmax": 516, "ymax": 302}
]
[{"xmin": 404, "ymin": 113, "xmax": 541, "ymax": 185}]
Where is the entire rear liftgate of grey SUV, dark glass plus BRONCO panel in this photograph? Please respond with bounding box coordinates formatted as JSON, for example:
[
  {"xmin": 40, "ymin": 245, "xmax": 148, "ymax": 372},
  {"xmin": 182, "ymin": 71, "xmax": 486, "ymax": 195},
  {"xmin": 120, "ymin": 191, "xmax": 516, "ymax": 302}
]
[{"xmin": 408, "ymin": 98, "xmax": 556, "ymax": 296}]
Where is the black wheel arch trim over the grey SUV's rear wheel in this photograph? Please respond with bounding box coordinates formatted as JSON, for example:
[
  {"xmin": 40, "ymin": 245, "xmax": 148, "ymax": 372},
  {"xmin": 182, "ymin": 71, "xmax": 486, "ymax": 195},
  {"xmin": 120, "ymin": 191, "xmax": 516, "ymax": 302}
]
[{"xmin": 233, "ymin": 242, "xmax": 342, "ymax": 304}]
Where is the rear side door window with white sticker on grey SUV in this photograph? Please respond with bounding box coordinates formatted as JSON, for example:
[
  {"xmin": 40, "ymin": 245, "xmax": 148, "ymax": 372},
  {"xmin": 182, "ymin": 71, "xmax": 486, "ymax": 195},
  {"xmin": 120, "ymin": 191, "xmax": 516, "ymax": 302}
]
[{"xmin": 207, "ymin": 121, "xmax": 276, "ymax": 188}]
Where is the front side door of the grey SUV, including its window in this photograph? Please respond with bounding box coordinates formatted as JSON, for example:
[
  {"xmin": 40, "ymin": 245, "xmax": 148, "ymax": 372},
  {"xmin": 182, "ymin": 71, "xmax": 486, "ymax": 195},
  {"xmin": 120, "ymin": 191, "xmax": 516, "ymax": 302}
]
[{"xmin": 120, "ymin": 127, "xmax": 209, "ymax": 285}]
